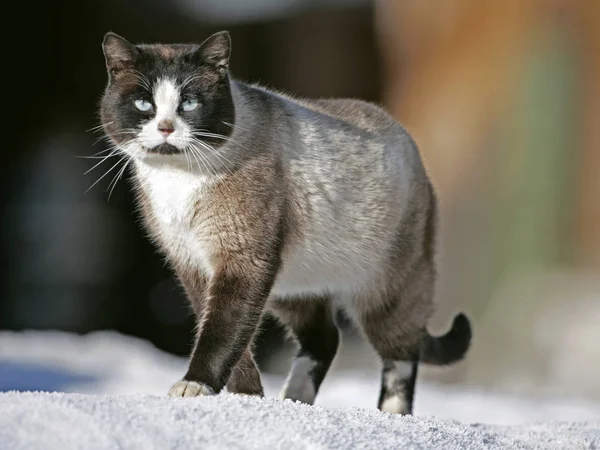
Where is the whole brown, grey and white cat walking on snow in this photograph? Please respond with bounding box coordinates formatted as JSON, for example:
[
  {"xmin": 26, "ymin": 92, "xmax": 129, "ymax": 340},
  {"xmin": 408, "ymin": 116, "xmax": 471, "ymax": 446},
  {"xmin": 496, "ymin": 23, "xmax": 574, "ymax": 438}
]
[{"xmin": 100, "ymin": 31, "xmax": 471, "ymax": 414}]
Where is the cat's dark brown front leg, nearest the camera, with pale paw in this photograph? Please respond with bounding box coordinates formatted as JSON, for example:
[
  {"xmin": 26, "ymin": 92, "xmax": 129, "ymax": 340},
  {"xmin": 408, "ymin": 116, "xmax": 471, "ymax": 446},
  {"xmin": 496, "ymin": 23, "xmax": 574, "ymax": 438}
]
[{"xmin": 169, "ymin": 254, "xmax": 278, "ymax": 397}]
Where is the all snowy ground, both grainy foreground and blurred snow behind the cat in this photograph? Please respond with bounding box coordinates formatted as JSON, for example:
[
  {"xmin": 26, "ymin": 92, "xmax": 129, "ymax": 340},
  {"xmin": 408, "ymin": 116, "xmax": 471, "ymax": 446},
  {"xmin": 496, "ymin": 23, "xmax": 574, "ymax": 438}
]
[{"xmin": 0, "ymin": 332, "xmax": 600, "ymax": 450}]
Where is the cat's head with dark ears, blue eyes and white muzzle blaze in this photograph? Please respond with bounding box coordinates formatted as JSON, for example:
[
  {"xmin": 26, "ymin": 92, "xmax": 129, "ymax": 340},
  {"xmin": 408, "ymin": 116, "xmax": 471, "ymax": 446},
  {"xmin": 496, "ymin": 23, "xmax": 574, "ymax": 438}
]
[{"xmin": 100, "ymin": 32, "xmax": 234, "ymax": 165}]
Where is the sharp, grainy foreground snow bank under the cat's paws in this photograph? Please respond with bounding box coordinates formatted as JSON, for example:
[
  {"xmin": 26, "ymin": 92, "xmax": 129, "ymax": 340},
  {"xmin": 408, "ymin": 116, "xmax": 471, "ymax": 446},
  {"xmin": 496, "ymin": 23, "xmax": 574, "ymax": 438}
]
[{"xmin": 0, "ymin": 392, "xmax": 600, "ymax": 450}]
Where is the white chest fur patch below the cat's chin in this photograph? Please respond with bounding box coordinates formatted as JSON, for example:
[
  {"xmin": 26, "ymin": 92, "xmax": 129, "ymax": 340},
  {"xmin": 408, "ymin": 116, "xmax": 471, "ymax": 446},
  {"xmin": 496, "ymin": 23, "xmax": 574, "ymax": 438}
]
[{"xmin": 138, "ymin": 165, "xmax": 215, "ymax": 276}]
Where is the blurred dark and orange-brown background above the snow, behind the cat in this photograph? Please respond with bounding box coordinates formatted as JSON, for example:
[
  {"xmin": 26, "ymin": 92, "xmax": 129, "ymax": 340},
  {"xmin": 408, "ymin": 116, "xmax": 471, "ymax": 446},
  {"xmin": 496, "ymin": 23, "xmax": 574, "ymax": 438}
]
[{"xmin": 0, "ymin": 0, "xmax": 600, "ymax": 401}]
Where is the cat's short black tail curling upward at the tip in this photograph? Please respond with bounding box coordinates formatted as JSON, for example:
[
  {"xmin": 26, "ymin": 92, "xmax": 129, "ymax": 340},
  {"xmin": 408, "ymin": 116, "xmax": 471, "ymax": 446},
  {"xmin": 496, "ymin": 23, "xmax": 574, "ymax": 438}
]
[{"xmin": 420, "ymin": 313, "xmax": 473, "ymax": 366}]
